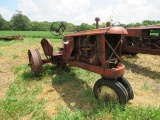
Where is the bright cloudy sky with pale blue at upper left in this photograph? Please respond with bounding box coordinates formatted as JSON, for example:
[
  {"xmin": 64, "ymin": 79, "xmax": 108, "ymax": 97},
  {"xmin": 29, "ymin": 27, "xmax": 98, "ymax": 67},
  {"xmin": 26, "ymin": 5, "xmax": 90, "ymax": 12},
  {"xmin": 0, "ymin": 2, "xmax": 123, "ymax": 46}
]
[{"xmin": 0, "ymin": 0, "xmax": 160, "ymax": 25}]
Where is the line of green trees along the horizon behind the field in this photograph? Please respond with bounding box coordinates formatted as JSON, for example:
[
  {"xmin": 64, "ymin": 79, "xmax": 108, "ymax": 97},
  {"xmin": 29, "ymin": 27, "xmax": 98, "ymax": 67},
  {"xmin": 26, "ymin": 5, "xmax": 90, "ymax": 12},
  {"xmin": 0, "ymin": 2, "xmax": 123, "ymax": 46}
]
[{"xmin": 0, "ymin": 11, "xmax": 160, "ymax": 32}]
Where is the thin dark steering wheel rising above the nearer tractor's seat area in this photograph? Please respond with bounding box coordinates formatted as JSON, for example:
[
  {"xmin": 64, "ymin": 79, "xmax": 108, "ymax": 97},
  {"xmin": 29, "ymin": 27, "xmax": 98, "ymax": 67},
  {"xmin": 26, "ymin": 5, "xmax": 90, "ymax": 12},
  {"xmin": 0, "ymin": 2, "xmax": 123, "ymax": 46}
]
[{"xmin": 50, "ymin": 22, "xmax": 66, "ymax": 36}]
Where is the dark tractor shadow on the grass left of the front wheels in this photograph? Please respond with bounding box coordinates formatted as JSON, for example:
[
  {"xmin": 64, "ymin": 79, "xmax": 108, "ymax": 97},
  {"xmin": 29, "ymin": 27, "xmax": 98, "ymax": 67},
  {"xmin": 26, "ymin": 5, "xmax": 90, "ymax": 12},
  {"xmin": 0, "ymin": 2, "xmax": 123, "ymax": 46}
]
[{"xmin": 49, "ymin": 67, "xmax": 98, "ymax": 110}]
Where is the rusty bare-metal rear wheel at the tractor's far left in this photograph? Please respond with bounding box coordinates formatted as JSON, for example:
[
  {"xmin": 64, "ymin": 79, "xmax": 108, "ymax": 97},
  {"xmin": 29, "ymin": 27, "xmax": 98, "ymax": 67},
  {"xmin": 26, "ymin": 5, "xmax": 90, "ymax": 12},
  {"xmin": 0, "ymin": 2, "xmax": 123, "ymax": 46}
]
[{"xmin": 28, "ymin": 49, "xmax": 43, "ymax": 76}]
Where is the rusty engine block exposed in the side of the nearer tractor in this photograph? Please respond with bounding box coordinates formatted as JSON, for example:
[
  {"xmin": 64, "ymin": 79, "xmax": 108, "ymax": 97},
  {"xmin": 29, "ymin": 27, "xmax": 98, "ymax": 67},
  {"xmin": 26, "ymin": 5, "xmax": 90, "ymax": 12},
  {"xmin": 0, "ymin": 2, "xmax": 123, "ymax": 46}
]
[{"xmin": 73, "ymin": 36, "xmax": 100, "ymax": 65}]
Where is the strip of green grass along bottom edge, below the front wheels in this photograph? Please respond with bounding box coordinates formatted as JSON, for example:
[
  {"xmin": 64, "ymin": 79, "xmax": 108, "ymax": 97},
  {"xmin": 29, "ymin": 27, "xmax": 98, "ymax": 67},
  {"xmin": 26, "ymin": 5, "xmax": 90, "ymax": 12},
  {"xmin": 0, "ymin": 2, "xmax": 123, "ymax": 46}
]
[{"xmin": 54, "ymin": 103, "xmax": 160, "ymax": 120}]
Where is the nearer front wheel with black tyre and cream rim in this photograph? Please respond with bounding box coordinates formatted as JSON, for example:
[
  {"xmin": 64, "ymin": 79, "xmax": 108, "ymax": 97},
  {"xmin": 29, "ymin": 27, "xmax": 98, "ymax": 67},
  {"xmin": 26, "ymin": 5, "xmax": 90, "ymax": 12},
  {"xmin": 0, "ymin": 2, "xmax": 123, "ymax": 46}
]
[{"xmin": 93, "ymin": 78, "xmax": 128, "ymax": 104}]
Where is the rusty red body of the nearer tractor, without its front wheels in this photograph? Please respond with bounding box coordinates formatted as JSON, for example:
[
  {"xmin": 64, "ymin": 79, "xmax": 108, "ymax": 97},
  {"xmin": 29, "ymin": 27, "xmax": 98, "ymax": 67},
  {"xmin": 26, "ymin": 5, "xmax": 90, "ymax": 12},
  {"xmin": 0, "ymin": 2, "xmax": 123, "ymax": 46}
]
[{"xmin": 29, "ymin": 18, "xmax": 127, "ymax": 78}]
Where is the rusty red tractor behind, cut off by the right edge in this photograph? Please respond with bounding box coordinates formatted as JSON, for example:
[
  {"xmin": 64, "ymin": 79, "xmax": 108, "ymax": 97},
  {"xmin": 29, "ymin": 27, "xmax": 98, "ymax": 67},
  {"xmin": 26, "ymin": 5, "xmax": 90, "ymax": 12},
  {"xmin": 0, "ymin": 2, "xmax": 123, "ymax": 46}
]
[{"xmin": 122, "ymin": 25, "xmax": 160, "ymax": 55}]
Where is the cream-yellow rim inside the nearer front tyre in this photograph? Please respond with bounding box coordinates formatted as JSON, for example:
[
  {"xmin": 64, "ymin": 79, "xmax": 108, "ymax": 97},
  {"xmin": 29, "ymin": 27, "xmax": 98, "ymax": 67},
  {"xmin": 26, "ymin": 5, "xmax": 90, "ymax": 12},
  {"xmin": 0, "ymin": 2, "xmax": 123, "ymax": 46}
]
[{"xmin": 97, "ymin": 85, "xmax": 119, "ymax": 102}]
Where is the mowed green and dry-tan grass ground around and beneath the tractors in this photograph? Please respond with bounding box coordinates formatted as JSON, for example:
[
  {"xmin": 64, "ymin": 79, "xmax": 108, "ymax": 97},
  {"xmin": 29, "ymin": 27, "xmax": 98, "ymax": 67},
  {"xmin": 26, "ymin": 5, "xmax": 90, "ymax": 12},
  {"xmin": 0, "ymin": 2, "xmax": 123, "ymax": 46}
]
[{"xmin": 0, "ymin": 32, "xmax": 160, "ymax": 120}]
